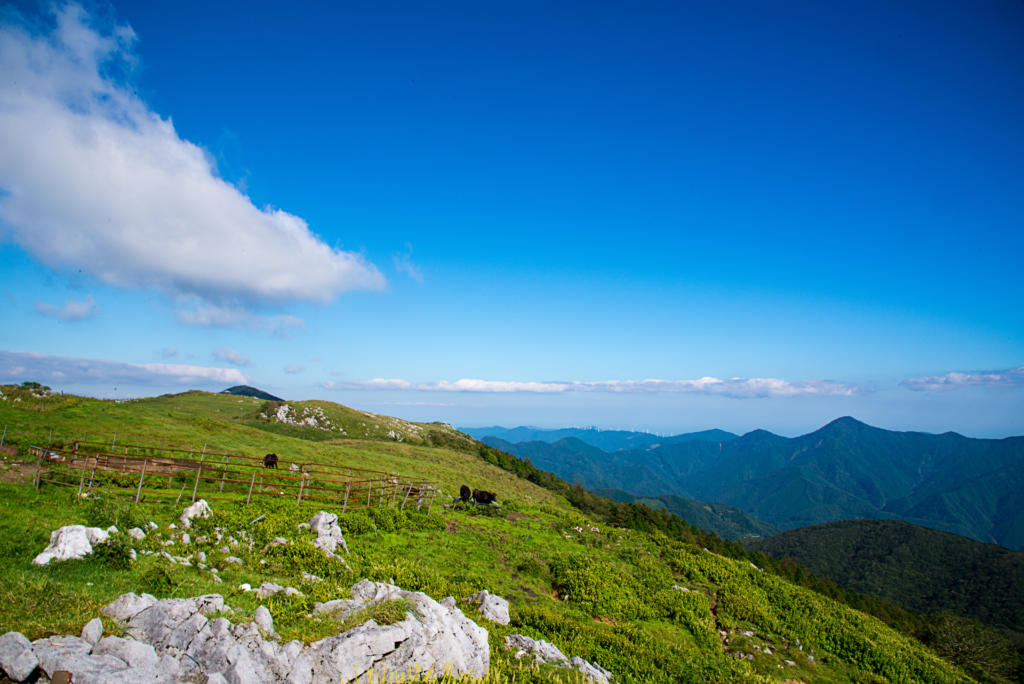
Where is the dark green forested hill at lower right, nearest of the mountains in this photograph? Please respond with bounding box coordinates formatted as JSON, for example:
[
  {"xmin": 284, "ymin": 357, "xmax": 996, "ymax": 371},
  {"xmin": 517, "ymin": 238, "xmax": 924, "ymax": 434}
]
[{"xmin": 743, "ymin": 520, "xmax": 1024, "ymax": 642}]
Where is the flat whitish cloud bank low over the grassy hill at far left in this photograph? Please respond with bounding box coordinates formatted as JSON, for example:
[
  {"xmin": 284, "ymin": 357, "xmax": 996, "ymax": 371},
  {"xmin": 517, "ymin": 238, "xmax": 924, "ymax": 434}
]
[{"xmin": 0, "ymin": 351, "xmax": 250, "ymax": 387}]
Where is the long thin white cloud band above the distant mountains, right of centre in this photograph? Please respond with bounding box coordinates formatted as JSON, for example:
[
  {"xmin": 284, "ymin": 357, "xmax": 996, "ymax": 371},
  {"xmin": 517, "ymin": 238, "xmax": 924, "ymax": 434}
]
[{"xmin": 322, "ymin": 377, "xmax": 870, "ymax": 398}]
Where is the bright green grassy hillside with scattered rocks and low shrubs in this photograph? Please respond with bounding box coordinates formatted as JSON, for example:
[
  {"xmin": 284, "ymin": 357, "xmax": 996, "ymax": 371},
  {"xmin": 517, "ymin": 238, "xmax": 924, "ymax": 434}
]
[{"xmin": 0, "ymin": 388, "xmax": 966, "ymax": 682}]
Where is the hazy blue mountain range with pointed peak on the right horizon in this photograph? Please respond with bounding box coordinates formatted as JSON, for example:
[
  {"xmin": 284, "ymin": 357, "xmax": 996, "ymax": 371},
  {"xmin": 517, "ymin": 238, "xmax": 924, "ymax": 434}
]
[{"xmin": 474, "ymin": 417, "xmax": 1024, "ymax": 549}]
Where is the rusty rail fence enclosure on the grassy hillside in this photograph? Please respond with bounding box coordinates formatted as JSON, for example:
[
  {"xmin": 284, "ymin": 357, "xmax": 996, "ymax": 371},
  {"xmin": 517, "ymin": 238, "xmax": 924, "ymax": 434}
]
[{"xmin": 30, "ymin": 441, "xmax": 438, "ymax": 513}]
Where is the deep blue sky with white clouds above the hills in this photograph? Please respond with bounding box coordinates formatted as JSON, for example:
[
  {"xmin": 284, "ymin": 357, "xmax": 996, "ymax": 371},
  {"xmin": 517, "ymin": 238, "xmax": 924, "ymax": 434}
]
[{"xmin": 0, "ymin": 1, "xmax": 1024, "ymax": 436}]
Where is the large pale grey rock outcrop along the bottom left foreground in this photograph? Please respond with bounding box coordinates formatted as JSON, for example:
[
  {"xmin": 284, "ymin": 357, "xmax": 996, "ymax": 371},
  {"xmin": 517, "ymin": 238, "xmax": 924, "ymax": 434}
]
[{"xmin": 0, "ymin": 580, "xmax": 489, "ymax": 684}]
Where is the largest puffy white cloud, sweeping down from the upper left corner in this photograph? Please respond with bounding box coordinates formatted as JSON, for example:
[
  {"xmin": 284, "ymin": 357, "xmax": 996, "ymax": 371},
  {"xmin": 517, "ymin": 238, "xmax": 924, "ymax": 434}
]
[{"xmin": 0, "ymin": 4, "xmax": 385, "ymax": 305}]
